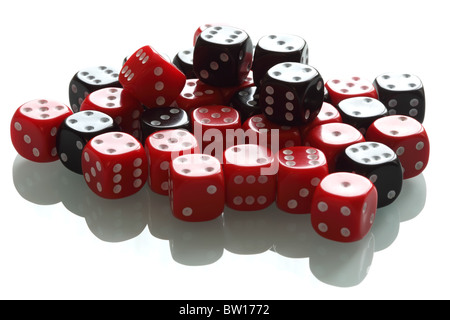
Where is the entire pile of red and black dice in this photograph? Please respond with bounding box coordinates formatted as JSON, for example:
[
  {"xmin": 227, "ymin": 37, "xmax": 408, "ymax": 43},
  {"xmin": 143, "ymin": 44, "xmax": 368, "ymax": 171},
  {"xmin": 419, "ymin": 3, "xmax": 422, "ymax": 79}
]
[{"xmin": 11, "ymin": 24, "xmax": 429, "ymax": 242}]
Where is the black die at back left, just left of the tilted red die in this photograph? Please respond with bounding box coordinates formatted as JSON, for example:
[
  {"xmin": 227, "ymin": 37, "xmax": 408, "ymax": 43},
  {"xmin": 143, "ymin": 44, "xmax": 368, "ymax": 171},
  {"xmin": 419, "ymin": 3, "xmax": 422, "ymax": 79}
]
[{"xmin": 69, "ymin": 66, "xmax": 122, "ymax": 112}]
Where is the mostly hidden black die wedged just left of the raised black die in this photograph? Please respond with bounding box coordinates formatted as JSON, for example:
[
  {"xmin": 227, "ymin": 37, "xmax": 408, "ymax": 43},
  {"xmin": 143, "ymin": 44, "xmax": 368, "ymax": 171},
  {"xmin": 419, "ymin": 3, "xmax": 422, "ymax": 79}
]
[{"xmin": 230, "ymin": 86, "xmax": 262, "ymax": 123}]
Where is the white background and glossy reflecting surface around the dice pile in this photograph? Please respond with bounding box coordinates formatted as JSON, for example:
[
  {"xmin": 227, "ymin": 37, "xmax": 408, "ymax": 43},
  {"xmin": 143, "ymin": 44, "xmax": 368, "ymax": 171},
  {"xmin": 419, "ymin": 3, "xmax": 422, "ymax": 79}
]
[{"xmin": 0, "ymin": 0, "xmax": 450, "ymax": 299}]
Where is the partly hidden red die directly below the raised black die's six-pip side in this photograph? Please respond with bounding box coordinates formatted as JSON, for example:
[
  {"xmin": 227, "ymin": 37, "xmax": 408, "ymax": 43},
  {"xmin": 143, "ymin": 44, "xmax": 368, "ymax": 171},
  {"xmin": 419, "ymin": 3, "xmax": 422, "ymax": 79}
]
[{"xmin": 242, "ymin": 114, "xmax": 301, "ymax": 152}]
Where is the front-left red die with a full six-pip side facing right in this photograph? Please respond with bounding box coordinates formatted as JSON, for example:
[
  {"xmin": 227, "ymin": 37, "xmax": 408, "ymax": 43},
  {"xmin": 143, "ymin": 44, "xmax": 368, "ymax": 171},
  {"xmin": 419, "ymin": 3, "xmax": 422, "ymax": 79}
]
[{"xmin": 81, "ymin": 132, "xmax": 148, "ymax": 199}]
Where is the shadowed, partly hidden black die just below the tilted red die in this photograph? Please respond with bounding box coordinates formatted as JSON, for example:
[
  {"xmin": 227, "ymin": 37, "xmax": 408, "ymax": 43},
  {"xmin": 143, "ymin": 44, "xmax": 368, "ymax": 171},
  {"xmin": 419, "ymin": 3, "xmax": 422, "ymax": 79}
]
[{"xmin": 141, "ymin": 107, "xmax": 191, "ymax": 143}]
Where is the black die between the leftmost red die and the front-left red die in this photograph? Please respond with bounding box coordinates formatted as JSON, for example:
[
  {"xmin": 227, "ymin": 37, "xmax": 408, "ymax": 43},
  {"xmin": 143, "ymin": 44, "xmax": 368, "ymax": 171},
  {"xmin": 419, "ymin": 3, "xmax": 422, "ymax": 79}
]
[{"xmin": 56, "ymin": 110, "xmax": 119, "ymax": 174}]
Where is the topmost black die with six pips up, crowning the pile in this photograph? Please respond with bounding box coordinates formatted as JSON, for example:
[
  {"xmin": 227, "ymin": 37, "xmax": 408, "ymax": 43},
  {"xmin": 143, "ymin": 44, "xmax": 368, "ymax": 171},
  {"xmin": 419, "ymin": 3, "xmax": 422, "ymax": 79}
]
[{"xmin": 194, "ymin": 26, "xmax": 253, "ymax": 87}]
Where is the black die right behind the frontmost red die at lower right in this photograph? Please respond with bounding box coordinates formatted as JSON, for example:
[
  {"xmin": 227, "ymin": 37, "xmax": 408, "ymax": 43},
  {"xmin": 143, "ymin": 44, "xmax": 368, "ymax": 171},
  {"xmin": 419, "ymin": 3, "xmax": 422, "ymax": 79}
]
[{"xmin": 336, "ymin": 141, "xmax": 403, "ymax": 208}]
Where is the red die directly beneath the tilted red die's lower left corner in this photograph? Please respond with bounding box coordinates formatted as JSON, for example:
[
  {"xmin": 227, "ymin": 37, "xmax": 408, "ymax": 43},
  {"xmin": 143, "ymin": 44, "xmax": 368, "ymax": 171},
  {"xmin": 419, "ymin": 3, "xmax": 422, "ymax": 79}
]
[{"xmin": 80, "ymin": 88, "xmax": 144, "ymax": 138}]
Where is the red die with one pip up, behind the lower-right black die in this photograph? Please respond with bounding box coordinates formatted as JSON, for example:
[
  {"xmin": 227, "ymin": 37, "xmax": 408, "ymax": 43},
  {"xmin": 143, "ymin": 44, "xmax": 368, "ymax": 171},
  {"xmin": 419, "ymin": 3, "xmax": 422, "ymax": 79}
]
[{"xmin": 305, "ymin": 122, "xmax": 366, "ymax": 172}]
